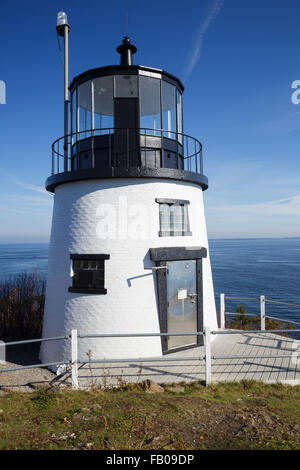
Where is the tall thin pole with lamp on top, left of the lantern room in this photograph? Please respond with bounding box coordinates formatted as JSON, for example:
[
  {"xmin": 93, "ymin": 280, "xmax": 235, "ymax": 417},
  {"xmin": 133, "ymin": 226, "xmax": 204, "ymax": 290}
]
[{"xmin": 56, "ymin": 11, "xmax": 71, "ymax": 171}]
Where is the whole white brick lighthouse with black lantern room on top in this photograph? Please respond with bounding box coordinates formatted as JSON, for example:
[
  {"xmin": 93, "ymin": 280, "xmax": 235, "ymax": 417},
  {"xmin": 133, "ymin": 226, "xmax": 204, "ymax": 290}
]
[{"xmin": 40, "ymin": 23, "xmax": 217, "ymax": 363}]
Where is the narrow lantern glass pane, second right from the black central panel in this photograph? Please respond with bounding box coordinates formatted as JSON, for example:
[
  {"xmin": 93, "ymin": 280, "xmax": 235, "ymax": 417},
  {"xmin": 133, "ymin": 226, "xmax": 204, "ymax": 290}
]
[{"xmin": 162, "ymin": 80, "xmax": 176, "ymax": 139}]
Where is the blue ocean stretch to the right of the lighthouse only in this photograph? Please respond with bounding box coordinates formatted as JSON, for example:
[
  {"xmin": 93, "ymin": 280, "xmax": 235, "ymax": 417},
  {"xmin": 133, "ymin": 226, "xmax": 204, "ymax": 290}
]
[{"xmin": 209, "ymin": 237, "xmax": 300, "ymax": 328}]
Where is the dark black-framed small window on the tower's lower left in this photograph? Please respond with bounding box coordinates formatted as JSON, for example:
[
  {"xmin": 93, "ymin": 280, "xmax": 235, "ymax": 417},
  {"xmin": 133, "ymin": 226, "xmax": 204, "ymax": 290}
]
[{"xmin": 69, "ymin": 254, "xmax": 109, "ymax": 294}]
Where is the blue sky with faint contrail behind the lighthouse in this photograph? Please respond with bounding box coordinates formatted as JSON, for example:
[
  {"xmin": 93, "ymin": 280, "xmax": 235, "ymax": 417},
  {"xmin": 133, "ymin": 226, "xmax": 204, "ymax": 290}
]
[{"xmin": 0, "ymin": 0, "xmax": 300, "ymax": 242}]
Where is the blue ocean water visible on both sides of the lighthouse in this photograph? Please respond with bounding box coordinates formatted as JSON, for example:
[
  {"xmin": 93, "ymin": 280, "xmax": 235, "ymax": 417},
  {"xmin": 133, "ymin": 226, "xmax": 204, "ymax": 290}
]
[{"xmin": 0, "ymin": 237, "xmax": 300, "ymax": 328}]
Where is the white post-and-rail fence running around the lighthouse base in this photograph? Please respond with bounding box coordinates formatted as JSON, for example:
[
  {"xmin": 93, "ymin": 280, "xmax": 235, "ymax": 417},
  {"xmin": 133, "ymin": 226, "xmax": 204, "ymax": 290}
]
[{"xmin": 0, "ymin": 293, "xmax": 300, "ymax": 389}]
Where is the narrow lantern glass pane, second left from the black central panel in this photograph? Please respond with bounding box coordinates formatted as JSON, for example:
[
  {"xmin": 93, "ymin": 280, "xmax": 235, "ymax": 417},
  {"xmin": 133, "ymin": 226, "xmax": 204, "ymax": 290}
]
[{"xmin": 78, "ymin": 80, "xmax": 92, "ymax": 139}]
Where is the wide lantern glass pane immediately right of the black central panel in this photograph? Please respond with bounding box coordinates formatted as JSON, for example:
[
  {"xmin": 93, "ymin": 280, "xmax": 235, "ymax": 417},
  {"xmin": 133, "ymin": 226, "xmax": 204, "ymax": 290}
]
[{"xmin": 139, "ymin": 75, "xmax": 161, "ymax": 135}]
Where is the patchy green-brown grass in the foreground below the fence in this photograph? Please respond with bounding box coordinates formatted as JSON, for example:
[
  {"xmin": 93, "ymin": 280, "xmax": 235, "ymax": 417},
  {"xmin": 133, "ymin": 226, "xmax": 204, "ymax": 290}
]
[{"xmin": 0, "ymin": 381, "xmax": 300, "ymax": 450}]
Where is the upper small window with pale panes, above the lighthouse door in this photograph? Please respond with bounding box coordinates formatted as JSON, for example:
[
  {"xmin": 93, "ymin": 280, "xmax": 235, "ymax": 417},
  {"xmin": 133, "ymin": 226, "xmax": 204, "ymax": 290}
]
[{"xmin": 155, "ymin": 199, "xmax": 192, "ymax": 237}]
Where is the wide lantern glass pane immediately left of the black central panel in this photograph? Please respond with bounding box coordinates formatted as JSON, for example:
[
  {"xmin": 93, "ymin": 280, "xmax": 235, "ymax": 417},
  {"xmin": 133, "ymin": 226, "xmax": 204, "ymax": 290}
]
[{"xmin": 93, "ymin": 76, "xmax": 114, "ymax": 135}]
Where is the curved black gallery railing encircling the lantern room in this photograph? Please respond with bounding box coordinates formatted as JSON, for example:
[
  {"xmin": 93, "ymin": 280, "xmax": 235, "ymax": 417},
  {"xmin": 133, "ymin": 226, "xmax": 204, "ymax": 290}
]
[{"xmin": 52, "ymin": 128, "xmax": 203, "ymax": 175}]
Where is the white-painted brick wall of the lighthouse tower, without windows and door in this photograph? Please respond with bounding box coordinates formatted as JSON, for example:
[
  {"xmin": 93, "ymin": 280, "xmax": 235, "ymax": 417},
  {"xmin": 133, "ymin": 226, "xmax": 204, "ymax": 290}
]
[{"xmin": 41, "ymin": 179, "xmax": 217, "ymax": 362}]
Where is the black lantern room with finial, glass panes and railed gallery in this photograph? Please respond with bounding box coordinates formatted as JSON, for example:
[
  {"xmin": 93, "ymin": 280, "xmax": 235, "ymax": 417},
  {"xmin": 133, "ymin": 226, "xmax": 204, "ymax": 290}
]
[{"xmin": 46, "ymin": 36, "xmax": 208, "ymax": 192}]
